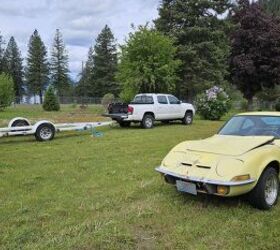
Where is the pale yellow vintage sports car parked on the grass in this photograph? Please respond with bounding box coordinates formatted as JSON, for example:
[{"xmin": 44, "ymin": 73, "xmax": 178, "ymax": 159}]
[{"xmin": 156, "ymin": 112, "xmax": 280, "ymax": 209}]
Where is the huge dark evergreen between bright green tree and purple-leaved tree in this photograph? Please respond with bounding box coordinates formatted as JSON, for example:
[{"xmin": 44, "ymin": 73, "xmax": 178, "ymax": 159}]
[{"xmin": 155, "ymin": 0, "xmax": 231, "ymax": 99}]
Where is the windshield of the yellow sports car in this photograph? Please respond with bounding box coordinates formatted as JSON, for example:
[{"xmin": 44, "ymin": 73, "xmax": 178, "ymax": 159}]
[{"xmin": 219, "ymin": 115, "xmax": 280, "ymax": 139}]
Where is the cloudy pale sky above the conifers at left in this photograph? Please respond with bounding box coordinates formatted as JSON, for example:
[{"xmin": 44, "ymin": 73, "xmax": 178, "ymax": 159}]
[{"xmin": 0, "ymin": 0, "xmax": 160, "ymax": 79}]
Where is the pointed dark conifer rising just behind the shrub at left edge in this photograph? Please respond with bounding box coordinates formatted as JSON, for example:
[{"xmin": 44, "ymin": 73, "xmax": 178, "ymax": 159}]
[{"xmin": 3, "ymin": 36, "xmax": 24, "ymax": 101}]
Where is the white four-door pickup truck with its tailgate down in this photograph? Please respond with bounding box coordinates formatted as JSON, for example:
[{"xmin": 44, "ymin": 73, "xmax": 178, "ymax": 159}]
[{"xmin": 104, "ymin": 94, "xmax": 195, "ymax": 128}]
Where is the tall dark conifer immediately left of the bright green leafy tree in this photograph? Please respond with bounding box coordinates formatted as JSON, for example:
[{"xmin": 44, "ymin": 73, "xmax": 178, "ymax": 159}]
[{"xmin": 91, "ymin": 25, "xmax": 119, "ymax": 97}]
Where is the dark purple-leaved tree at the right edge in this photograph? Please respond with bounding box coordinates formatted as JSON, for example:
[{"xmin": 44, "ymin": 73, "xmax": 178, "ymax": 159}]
[{"xmin": 230, "ymin": 0, "xmax": 280, "ymax": 109}]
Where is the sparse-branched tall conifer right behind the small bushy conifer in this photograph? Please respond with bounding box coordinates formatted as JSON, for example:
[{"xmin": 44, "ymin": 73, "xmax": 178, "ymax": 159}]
[{"xmin": 50, "ymin": 29, "xmax": 70, "ymax": 96}]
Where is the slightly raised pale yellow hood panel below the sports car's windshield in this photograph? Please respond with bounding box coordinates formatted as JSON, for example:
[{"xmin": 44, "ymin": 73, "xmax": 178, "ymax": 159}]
[{"xmin": 185, "ymin": 135, "xmax": 274, "ymax": 156}]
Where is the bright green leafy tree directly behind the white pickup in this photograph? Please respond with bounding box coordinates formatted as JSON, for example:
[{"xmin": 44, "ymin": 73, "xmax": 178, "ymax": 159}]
[{"xmin": 118, "ymin": 26, "xmax": 180, "ymax": 101}]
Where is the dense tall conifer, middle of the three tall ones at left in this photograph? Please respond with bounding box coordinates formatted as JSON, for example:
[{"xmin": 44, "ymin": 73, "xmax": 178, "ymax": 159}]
[{"xmin": 25, "ymin": 30, "xmax": 49, "ymax": 103}]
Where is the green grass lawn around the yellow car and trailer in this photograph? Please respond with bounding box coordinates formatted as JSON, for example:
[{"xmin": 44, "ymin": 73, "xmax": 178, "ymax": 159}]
[{"xmin": 0, "ymin": 106, "xmax": 280, "ymax": 249}]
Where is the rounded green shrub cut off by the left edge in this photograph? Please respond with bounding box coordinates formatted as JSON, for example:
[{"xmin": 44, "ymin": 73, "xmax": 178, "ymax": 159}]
[{"xmin": 0, "ymin": 74, "xmax": 15, "ymax": 110}]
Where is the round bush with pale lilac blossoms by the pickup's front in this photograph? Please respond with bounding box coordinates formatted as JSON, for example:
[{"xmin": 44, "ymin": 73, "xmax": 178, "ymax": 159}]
[{"xmin": 196, "ymin": 86, "xmax": 230, "ymax": 120}]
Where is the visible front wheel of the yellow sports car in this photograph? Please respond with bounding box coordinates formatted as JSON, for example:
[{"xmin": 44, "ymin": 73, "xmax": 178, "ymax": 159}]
[{"xmin": 248, "ymin": 167, "xmax": 279, "ymax": 210}]
